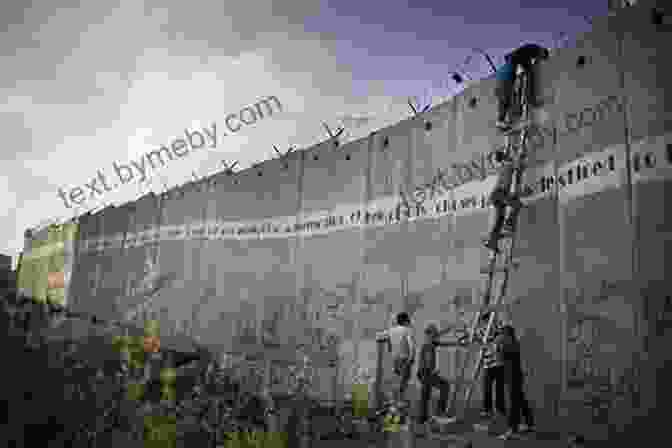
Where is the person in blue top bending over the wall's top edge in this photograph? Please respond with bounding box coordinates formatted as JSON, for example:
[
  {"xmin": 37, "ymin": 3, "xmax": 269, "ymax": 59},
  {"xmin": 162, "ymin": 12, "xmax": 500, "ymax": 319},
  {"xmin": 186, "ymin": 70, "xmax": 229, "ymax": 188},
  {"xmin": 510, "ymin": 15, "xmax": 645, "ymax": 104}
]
[{"xmin": 495, "ymin": 44, "xmax": 549, "ymax": 129}]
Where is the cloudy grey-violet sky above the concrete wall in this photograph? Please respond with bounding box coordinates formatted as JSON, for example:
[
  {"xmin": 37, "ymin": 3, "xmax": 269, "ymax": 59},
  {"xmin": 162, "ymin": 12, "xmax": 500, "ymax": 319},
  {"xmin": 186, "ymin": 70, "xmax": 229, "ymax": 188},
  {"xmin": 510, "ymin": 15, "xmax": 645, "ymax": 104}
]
[{"xmin": 0, "ymin": 0, "xmax": 607, "ymax": 263}]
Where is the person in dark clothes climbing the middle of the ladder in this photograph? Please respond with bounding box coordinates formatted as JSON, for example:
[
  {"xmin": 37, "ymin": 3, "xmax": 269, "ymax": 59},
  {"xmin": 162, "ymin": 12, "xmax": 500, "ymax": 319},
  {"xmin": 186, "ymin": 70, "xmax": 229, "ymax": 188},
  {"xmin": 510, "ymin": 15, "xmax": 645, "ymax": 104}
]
[{"xmin": 485, "ymin": 151, "xmax": 523, "ymax": 252}]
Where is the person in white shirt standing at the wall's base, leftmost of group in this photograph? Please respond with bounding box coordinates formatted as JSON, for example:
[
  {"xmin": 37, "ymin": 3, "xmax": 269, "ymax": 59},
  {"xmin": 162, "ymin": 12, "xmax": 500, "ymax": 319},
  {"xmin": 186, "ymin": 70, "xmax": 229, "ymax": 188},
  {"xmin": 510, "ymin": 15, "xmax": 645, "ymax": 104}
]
[{"xmin": 388, "ymin": 312, "xmax": 415, "ymax": 401}]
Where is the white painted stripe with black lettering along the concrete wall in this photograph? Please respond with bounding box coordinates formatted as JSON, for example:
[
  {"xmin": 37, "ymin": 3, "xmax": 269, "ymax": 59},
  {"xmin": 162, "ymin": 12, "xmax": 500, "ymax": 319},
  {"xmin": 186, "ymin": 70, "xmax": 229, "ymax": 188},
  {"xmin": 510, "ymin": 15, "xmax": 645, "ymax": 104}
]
[{"xmin": 22, "ymin": 134, "xmax": 672, "ymax": 255}]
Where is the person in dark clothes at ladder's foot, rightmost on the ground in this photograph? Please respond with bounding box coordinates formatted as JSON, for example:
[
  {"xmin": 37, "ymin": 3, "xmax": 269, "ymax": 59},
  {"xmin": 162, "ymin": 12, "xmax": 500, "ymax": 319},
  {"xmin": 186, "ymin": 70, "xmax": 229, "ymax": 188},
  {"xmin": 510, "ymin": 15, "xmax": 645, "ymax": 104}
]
[{"xmin": 499, "ymin": 325, "xmax": 534, "ymax": 440}]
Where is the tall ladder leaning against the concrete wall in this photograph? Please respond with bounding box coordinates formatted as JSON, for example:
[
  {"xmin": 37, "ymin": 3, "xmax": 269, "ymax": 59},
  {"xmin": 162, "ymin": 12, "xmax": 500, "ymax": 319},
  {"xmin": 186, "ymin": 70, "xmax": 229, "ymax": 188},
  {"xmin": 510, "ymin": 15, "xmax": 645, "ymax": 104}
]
[{"xmin": 450, "ymin": 68, "xmax": 530, "ymax": 419}]
